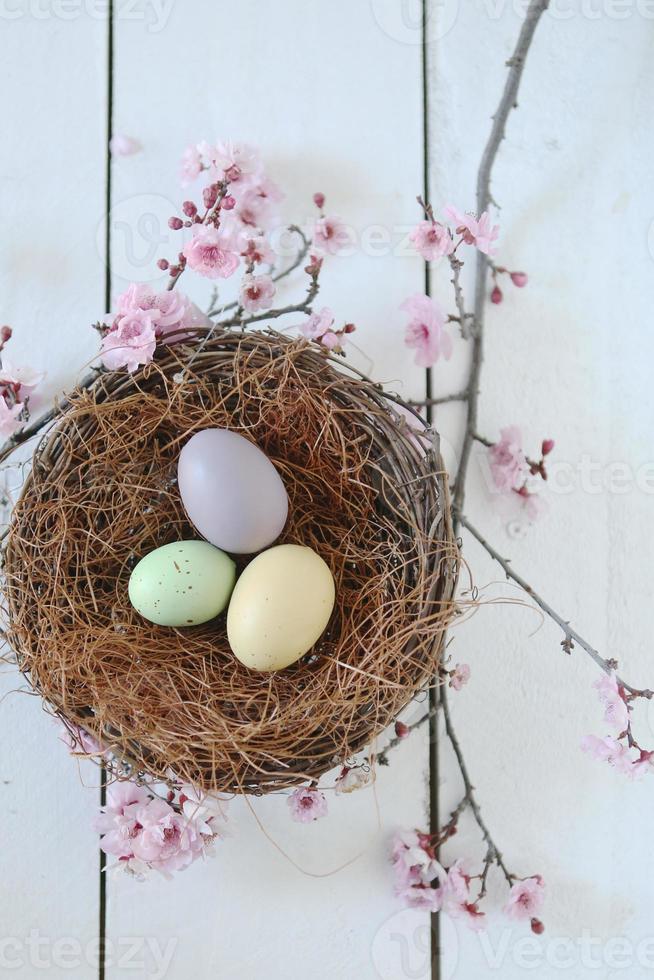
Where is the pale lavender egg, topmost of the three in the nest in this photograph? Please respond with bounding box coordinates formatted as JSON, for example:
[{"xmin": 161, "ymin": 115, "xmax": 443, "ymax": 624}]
[{"xmin": 177, "ymin": 429, "xmax": 288, "ymax": 555}]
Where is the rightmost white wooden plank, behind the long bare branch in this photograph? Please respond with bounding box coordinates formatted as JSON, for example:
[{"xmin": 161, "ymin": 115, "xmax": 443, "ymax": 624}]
[{"xmin": 430, "ymin": 4, "xmax": 654, "ymax": 980}]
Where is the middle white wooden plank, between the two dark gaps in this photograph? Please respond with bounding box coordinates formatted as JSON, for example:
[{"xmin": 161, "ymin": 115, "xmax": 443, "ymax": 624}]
[{"xmin": 107, "ymin": 0, "xmax": 429, "ymax": 980}]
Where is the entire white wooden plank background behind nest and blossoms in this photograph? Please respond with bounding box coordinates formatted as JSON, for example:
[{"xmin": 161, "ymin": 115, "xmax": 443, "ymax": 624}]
[{"xmin": 0, "ymin": 0, "xmax": 654, "ymax": 980}]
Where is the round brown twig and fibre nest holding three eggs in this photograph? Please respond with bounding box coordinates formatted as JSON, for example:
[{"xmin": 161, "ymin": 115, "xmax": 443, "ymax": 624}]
[{"xmin": 4, "ymin": 331, "xmax": 459, "ymax": 793}]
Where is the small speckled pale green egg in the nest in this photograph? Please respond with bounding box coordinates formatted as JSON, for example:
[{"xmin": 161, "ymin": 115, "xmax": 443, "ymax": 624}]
[{"xmin": 128, "ymin": 541, "xmax": 236, "ymax": 626}]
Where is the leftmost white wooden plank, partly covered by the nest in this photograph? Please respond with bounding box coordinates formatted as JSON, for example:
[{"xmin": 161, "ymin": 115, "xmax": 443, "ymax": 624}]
[{"xmin": 0, "ymin": 5, "xmax": 106, "ymax": 980}]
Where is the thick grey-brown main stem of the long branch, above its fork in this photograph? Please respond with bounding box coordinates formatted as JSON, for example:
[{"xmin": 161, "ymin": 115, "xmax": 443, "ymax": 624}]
[{"xmin": 452, "ymin": 0, "xmax": 549, "ymax": 528}]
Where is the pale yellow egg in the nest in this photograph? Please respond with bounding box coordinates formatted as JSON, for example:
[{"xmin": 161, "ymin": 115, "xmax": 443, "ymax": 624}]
[{"xmin": 227, "ymin": 544, "xmax": 335, "ymax": 671}]
